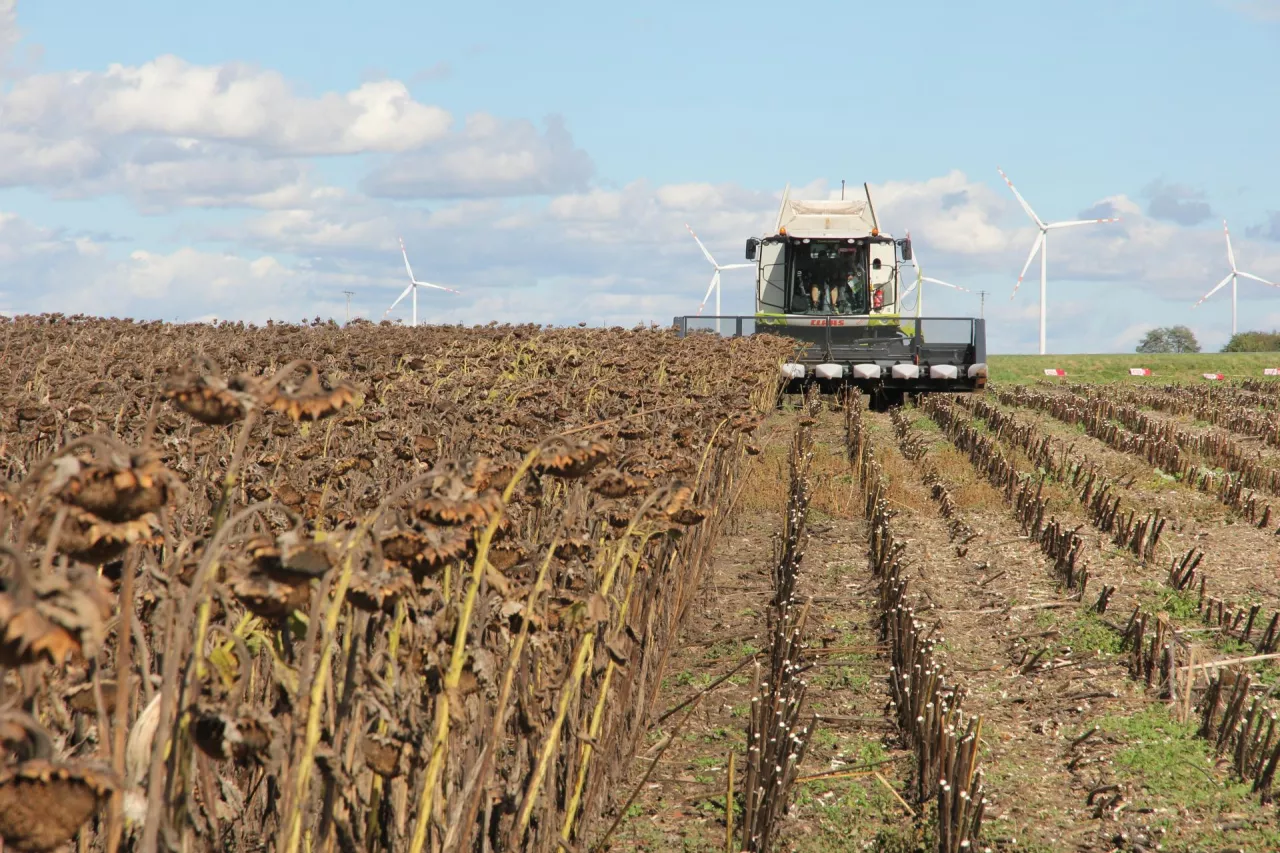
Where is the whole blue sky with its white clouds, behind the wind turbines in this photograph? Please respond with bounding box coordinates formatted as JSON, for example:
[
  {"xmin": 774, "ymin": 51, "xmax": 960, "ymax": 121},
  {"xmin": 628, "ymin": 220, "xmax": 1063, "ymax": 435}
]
[{"xmin": 0, "ymin": 0, "xmax": 1280, "ymax": 352}]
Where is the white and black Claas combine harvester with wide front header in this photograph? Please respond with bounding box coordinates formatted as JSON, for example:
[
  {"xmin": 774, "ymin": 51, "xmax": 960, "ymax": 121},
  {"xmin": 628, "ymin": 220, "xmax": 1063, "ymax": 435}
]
[{"xmin": 675, "ymin": 184, "xmax": 987, "ymax": 411}]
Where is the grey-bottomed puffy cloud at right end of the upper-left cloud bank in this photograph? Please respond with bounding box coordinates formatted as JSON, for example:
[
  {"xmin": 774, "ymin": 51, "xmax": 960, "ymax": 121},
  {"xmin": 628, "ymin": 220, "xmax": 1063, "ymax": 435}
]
[{"xmin": 362, "ymin": 113, "xmax": 595, "ymax": 199}]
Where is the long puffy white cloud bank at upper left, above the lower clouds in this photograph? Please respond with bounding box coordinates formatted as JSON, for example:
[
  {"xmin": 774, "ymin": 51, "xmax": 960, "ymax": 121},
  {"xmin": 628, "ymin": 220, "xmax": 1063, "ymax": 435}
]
[{"xmin": 0, "ymin": 49, "xmax": 594, "ymax": 211}]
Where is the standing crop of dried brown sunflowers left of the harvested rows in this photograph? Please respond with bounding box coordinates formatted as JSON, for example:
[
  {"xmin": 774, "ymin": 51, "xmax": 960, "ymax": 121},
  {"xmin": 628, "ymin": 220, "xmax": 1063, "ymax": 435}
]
[{"xmin": 0, "ymin": 315, "xmax": 791, "ymax": 853}]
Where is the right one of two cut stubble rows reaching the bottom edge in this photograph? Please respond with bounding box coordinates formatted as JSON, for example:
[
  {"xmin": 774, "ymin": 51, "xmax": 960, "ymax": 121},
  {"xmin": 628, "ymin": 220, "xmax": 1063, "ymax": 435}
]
[{"xmin": 845, "ymin": 396, "xmax": 987, "ymax": 853}]
